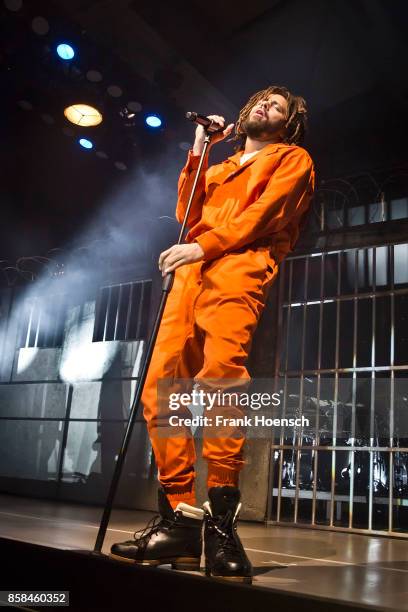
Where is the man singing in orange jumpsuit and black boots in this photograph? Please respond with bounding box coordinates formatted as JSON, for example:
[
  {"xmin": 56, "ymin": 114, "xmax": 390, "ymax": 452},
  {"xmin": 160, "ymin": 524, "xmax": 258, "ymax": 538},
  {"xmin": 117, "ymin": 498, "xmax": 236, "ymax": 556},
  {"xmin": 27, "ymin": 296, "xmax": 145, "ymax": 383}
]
[{"xmin": 111, "ymin": 86, "xmax": 314, "ymax": 583}]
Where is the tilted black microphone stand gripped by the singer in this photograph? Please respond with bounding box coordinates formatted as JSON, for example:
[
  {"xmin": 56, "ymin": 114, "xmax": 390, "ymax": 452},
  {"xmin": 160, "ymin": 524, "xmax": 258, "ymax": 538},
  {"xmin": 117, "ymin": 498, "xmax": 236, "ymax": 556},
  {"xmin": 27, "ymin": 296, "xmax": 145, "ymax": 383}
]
[{"xmin": 93, "ymin": 131, "xmax": 211, "ymax": 554}]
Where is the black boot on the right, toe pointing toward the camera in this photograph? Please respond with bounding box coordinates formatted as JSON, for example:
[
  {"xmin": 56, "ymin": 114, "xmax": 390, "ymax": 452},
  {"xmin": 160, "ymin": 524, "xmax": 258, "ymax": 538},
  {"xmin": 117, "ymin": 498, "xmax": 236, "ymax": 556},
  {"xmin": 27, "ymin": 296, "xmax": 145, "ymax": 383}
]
[{"xmin": 203, "ymin": 487, "xmax": 252, "ymax": 584}]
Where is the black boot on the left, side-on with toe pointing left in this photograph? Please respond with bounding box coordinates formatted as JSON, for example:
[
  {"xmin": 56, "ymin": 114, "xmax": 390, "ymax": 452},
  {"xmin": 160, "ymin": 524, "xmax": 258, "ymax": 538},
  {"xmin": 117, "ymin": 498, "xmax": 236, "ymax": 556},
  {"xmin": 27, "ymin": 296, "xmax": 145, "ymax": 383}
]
[{"xmin": 110, "ymin": 489, "xmax": 203, "ymax": 571}]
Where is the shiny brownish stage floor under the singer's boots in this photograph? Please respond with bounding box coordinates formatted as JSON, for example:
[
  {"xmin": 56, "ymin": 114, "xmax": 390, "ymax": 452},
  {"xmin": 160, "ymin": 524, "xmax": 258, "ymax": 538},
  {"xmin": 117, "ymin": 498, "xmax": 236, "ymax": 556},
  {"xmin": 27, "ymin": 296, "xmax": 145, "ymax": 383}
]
[{"xmin": 0, "ymin": 495, "xmax": 408, "ymax": 610}]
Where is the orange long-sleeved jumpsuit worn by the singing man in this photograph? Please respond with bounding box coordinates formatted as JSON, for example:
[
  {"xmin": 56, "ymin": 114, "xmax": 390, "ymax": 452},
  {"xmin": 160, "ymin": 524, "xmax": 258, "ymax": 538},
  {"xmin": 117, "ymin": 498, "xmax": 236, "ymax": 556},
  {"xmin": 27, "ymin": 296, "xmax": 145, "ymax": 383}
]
[{"xmin": 142, "ymin": 143, "xmax": 314, "ymax": 507}]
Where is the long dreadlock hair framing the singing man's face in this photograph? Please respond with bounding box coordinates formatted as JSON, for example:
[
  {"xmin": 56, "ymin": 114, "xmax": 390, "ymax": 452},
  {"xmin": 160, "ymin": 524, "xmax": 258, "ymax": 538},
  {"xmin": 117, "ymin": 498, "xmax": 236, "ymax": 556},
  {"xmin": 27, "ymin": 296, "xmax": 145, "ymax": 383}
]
[{"xmin": 234, "ymin": 85, "xmax": 307, "ymax": 150}]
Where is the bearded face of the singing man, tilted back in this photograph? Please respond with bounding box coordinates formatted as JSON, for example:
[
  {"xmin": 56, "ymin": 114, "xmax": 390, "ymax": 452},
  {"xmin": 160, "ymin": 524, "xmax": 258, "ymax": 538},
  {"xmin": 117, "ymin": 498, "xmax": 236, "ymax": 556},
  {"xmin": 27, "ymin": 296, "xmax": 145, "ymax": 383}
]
[{"xmin": 243, "ymin": 94, "xmax": 288, "ymax": 140}]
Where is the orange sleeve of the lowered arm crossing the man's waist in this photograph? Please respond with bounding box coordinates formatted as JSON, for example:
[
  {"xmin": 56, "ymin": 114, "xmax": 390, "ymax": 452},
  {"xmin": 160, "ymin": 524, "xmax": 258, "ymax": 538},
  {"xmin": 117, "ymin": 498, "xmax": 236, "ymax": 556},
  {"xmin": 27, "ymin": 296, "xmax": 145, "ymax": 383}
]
[{"xmin": 195, "ymin": 147, "xmax": 314, "ymax": 260}]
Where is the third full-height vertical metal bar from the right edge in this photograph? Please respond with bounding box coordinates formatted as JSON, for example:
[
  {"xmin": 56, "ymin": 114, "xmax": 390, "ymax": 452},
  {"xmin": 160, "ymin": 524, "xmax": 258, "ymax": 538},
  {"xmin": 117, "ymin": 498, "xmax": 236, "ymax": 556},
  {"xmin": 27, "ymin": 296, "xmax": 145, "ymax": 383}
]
[{"xmin": 349, "ymin": 249, "xmax": 356, "ymax": 529}]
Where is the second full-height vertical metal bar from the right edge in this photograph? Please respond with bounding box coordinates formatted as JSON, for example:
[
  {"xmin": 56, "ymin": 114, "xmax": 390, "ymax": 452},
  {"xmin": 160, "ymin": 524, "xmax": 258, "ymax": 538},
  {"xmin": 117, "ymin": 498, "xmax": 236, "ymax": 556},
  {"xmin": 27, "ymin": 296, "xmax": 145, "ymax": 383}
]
[{"xmin": 368, "ymin": 248, "xmax": 378, "ymax": 531}]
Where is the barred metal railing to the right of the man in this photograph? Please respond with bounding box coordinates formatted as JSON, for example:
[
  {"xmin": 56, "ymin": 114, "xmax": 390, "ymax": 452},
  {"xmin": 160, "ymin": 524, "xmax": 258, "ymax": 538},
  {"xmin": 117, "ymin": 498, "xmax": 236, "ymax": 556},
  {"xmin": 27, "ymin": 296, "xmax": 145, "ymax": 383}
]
[{"xmin": 269, "ymin": 244, "xmax": 408, "ymax": 537}]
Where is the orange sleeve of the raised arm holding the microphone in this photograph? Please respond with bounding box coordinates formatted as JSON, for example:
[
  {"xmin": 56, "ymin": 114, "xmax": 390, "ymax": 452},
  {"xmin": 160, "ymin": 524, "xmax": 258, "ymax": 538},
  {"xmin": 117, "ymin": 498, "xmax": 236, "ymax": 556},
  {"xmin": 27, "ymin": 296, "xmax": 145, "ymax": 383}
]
[{"xmin": 176, "ymin": 150, "xmax": 208, "ymax": 228}]
